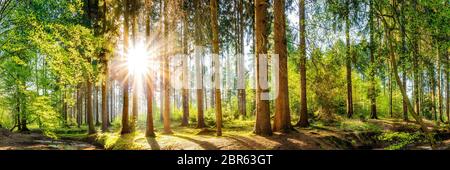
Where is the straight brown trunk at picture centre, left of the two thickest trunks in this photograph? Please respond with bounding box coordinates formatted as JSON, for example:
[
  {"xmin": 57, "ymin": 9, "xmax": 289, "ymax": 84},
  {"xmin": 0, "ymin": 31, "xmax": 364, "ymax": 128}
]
[{"xmin": 210, "ymin": 0, "xmax": 222, "ymax": 136}]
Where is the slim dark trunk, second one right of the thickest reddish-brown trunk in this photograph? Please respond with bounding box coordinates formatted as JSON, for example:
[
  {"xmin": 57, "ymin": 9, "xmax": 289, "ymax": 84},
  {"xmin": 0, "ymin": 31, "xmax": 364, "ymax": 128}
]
[{"xmin": 345, "ymin": 0, "xmax": 353, "ymax": 118}]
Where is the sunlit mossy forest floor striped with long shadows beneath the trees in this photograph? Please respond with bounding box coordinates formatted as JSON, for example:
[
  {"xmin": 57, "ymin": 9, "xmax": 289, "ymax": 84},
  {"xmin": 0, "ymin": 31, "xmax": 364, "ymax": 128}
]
[{"xmin": 0, "ymin": 119, "xmax": 450, "ymax": 150}]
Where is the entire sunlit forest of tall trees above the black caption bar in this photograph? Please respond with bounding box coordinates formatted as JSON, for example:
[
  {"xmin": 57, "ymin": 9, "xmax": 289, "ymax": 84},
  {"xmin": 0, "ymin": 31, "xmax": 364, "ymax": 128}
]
[{"xmin": 0, "ymin": 0, "xmax": 450, "ymax": 150}]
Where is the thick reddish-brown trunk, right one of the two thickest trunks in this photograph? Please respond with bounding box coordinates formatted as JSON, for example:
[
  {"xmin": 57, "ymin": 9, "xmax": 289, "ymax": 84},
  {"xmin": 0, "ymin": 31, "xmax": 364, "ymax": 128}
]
[{"xmin": 273, "ymin": 0, "xmax": 291, "ymax": 132}]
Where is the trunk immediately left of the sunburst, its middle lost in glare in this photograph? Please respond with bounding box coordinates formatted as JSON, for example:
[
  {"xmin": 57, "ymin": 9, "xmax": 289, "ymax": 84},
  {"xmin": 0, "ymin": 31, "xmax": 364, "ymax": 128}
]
[{"xmin": 121, "ymin": 0, "xmax": 131, "ymax": 134}]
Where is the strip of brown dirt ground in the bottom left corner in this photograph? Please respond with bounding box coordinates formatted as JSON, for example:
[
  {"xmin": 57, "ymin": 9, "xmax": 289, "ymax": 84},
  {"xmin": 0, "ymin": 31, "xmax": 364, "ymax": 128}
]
[{"xmin": 0, "ymin": 130, "xmax": 101, "ymax": 150}]
